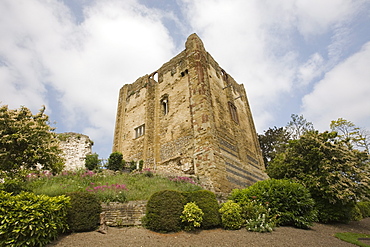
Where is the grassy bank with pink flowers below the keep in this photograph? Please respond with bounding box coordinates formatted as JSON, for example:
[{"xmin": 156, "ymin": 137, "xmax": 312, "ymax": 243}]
[{"xmin": 27, "ymin": 170, "xmax": 202, "ymax": 202}]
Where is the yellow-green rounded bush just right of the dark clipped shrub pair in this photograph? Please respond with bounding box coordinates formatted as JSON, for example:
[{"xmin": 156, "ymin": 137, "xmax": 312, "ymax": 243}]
[{"xmin": 219, "ymin": 200, "xmax": 244, "ymax": 230}]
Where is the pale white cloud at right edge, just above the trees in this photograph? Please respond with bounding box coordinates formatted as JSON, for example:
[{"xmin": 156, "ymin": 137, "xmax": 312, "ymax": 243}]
[{"xmin": 303, "ymin": 42, "xmax": 370, "ymax": 130}]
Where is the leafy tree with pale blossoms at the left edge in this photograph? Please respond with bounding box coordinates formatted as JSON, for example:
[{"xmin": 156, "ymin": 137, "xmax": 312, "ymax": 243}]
[{"xmin": 0, "ymin": 105, "xmax": 63, "ymax": 175}]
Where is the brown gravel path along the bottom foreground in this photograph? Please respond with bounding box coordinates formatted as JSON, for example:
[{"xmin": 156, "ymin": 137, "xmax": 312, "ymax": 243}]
[{"xmin": 48, "ymin": 218, "xmax": 370, "ymax": 247}]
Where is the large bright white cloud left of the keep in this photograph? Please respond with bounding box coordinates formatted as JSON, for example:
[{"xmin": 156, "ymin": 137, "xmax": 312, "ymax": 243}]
[{"xmin": 0, "ymin": 0, "xmax": 175, "ymax": 156}]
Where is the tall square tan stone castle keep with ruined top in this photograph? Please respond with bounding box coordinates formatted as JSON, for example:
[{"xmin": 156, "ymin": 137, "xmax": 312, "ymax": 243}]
[{"xmin": 113, "ymin": 34, "xmax": 267, "ymax": 192}]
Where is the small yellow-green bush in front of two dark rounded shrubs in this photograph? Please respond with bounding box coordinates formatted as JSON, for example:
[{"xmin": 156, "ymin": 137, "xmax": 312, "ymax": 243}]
[{"xmin": 180, "ymin": 202, "xmax": 204, "ymax": 231}]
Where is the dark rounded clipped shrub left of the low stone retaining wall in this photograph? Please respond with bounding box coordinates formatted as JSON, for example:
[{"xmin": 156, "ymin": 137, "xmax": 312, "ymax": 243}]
[{"xmin": 67, "ymin": 192, "xmax": 102, "ymax": 232}]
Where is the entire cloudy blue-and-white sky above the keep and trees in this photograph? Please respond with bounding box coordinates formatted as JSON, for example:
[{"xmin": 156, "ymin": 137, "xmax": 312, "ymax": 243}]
[{"xmin": 0, "ymin": 0, "xmax": 370, "ymax": 158}]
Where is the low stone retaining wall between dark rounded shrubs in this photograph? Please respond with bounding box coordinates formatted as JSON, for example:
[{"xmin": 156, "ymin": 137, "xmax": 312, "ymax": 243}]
[{"xmin": 102, "ymin": 201, "xmax": 147, "ymax": 226}]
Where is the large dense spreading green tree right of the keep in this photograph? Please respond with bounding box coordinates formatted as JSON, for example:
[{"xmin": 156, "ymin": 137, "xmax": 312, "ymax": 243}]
[{"xmin": 267, "ymin": 131, "xmax": 370, "ymax": 222}]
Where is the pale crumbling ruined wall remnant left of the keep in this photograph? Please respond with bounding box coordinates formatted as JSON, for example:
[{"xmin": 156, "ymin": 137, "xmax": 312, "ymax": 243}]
[{"xmin": 58, "ymin": 132, "xmax": 93, "ymax": 170}]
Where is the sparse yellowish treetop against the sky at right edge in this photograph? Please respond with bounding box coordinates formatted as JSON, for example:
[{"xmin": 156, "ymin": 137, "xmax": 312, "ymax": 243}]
[{"xmin": 330, "ymin": 118, "xmax": 370, "ymax": 153}]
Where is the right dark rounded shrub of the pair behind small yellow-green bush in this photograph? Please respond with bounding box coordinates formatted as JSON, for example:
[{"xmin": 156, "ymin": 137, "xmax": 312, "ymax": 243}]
[{"xmin": 183, "ymin": 190, "xmax": 221, "ymax": 229}]
